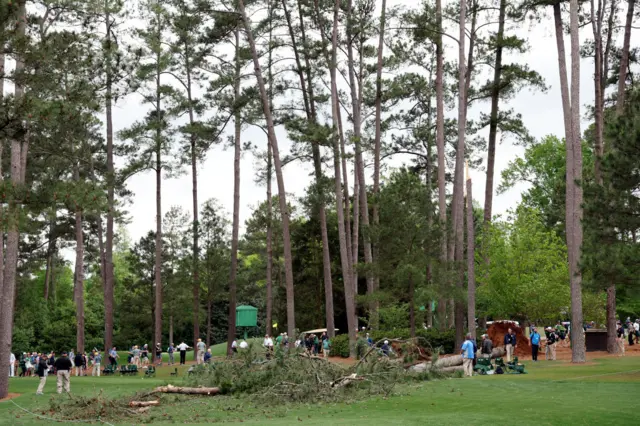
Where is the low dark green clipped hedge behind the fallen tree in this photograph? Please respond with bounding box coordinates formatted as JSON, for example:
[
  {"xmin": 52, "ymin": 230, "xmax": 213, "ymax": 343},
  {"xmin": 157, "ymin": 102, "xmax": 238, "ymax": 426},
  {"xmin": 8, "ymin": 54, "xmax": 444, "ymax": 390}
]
[{"xmin": 331, "ymin": 328, "xmax": 455, "ymax": 358}]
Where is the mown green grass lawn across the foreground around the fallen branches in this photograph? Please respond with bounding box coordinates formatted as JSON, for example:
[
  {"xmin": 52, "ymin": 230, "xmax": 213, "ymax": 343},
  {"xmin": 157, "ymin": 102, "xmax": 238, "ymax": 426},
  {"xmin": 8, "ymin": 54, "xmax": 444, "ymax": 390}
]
[{"xmin": 0, "ymin": 357, "xmax": 640, "ymax": 426}]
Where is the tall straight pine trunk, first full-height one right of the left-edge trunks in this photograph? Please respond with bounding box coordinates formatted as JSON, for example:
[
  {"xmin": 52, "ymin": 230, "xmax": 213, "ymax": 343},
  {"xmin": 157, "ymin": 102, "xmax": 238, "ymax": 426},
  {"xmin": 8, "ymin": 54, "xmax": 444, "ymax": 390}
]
[{"xmin": 104, "ymin": 5, "xmax": 116, "ymax": 351}]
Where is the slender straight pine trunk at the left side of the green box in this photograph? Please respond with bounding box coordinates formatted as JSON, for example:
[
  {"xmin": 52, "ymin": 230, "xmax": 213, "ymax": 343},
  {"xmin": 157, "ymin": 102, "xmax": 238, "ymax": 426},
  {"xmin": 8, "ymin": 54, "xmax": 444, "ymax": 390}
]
[{"xmin": 227, "ymin": 28, "xmax": 242, "ymax": 356}]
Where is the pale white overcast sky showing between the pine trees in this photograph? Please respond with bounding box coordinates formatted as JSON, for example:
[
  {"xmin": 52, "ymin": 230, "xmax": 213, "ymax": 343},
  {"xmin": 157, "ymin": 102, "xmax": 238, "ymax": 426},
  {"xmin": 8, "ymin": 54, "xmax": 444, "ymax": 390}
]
[{"xmin": 114, "ymin": 0, "xmax": 600, "ymax": 245}]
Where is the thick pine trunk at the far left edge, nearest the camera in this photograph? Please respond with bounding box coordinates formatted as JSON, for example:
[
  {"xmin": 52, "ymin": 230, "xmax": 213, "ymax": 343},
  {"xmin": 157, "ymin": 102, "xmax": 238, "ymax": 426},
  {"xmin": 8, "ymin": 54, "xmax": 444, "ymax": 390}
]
[{"xmin": 0, "ymin": 0, "xmax": 28, "ymax": 399}]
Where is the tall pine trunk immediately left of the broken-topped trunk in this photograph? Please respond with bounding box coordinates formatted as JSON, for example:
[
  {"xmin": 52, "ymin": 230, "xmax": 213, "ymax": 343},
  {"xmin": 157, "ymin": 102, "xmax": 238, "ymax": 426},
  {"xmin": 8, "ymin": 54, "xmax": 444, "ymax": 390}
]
[{"xmin": 449, "ymin": 2, "xmax": 467, "ymax": 347}]
